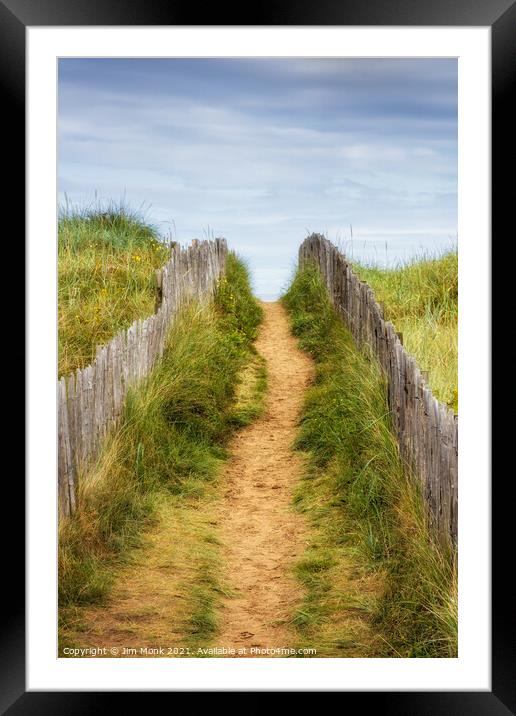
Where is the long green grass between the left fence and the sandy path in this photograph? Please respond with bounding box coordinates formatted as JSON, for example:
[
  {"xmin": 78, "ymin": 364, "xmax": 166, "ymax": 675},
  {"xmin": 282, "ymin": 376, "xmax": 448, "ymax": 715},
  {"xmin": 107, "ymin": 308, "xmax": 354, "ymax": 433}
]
[{"xmin": 59, "ymin": 254, "xmax": 265, "ymax": 641}]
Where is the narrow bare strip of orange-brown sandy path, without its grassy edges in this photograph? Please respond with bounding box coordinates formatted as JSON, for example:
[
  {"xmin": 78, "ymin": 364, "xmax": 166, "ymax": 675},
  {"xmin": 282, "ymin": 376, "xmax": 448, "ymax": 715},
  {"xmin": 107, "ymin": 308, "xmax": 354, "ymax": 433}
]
[{"xmin": 216, "ymin": 303, "xmax": 313, "ymax": 656}]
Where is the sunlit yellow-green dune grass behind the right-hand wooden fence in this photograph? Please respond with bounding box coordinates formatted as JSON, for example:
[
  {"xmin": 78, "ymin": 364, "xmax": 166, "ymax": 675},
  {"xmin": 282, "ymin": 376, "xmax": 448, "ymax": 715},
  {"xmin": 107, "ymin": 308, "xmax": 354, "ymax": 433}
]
[{"xmin": 354, "ymin": 251, "xmax": 458, "ymax": 413}]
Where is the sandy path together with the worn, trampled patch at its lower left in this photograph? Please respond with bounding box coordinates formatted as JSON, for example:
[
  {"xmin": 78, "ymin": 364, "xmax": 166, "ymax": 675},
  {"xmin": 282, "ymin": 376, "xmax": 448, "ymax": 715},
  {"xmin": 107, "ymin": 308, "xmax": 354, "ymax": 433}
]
[{"xmin": 62, "ymin": 303, "xmax": 313, "ymax": 657}]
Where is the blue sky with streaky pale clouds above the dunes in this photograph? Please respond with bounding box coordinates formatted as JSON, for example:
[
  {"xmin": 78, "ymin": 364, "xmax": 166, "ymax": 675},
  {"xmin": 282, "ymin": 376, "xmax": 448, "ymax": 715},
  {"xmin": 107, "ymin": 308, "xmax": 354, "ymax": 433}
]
[{"xmin": 58, "ymin": 58, "xmax": 457, "ymax": 299}]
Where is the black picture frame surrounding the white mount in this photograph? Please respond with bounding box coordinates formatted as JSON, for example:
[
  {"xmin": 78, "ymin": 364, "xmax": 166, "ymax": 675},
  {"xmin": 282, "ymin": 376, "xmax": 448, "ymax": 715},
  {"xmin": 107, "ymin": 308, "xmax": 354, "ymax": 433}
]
[{"xmin": 7, "ymin": 0, "xmax": 516, "ymax": 716}]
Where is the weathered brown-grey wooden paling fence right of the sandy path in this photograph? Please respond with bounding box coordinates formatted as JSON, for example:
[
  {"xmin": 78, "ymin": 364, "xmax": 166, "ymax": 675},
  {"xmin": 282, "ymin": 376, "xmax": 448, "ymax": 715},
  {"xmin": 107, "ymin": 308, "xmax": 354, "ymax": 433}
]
[{"xmin": 299, "ymin": 234, "xmax": 458, "ymax": 544}]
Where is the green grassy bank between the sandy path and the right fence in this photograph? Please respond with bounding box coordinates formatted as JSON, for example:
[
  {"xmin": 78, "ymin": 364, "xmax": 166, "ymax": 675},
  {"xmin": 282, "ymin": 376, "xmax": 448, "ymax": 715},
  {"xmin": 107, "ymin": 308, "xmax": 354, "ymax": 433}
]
[{"xmin": 283, "ymin": 267, "xmax": 457, "ymax": 657}]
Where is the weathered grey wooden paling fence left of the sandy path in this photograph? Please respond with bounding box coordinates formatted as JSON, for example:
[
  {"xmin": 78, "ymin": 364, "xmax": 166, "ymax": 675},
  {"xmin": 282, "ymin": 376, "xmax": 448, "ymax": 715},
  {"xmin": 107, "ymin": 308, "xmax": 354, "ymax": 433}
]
[{"xmin": 57, "ymin": 239, "xmax": 227, "ymax": 516}]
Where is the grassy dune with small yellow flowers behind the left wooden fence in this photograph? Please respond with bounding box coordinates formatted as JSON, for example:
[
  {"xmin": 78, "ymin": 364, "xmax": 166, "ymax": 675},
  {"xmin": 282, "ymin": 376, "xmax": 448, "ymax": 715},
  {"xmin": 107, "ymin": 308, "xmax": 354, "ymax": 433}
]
[{"xmin": 58, "ymin": 204, "xmax": 169, "ymax": 376}]
